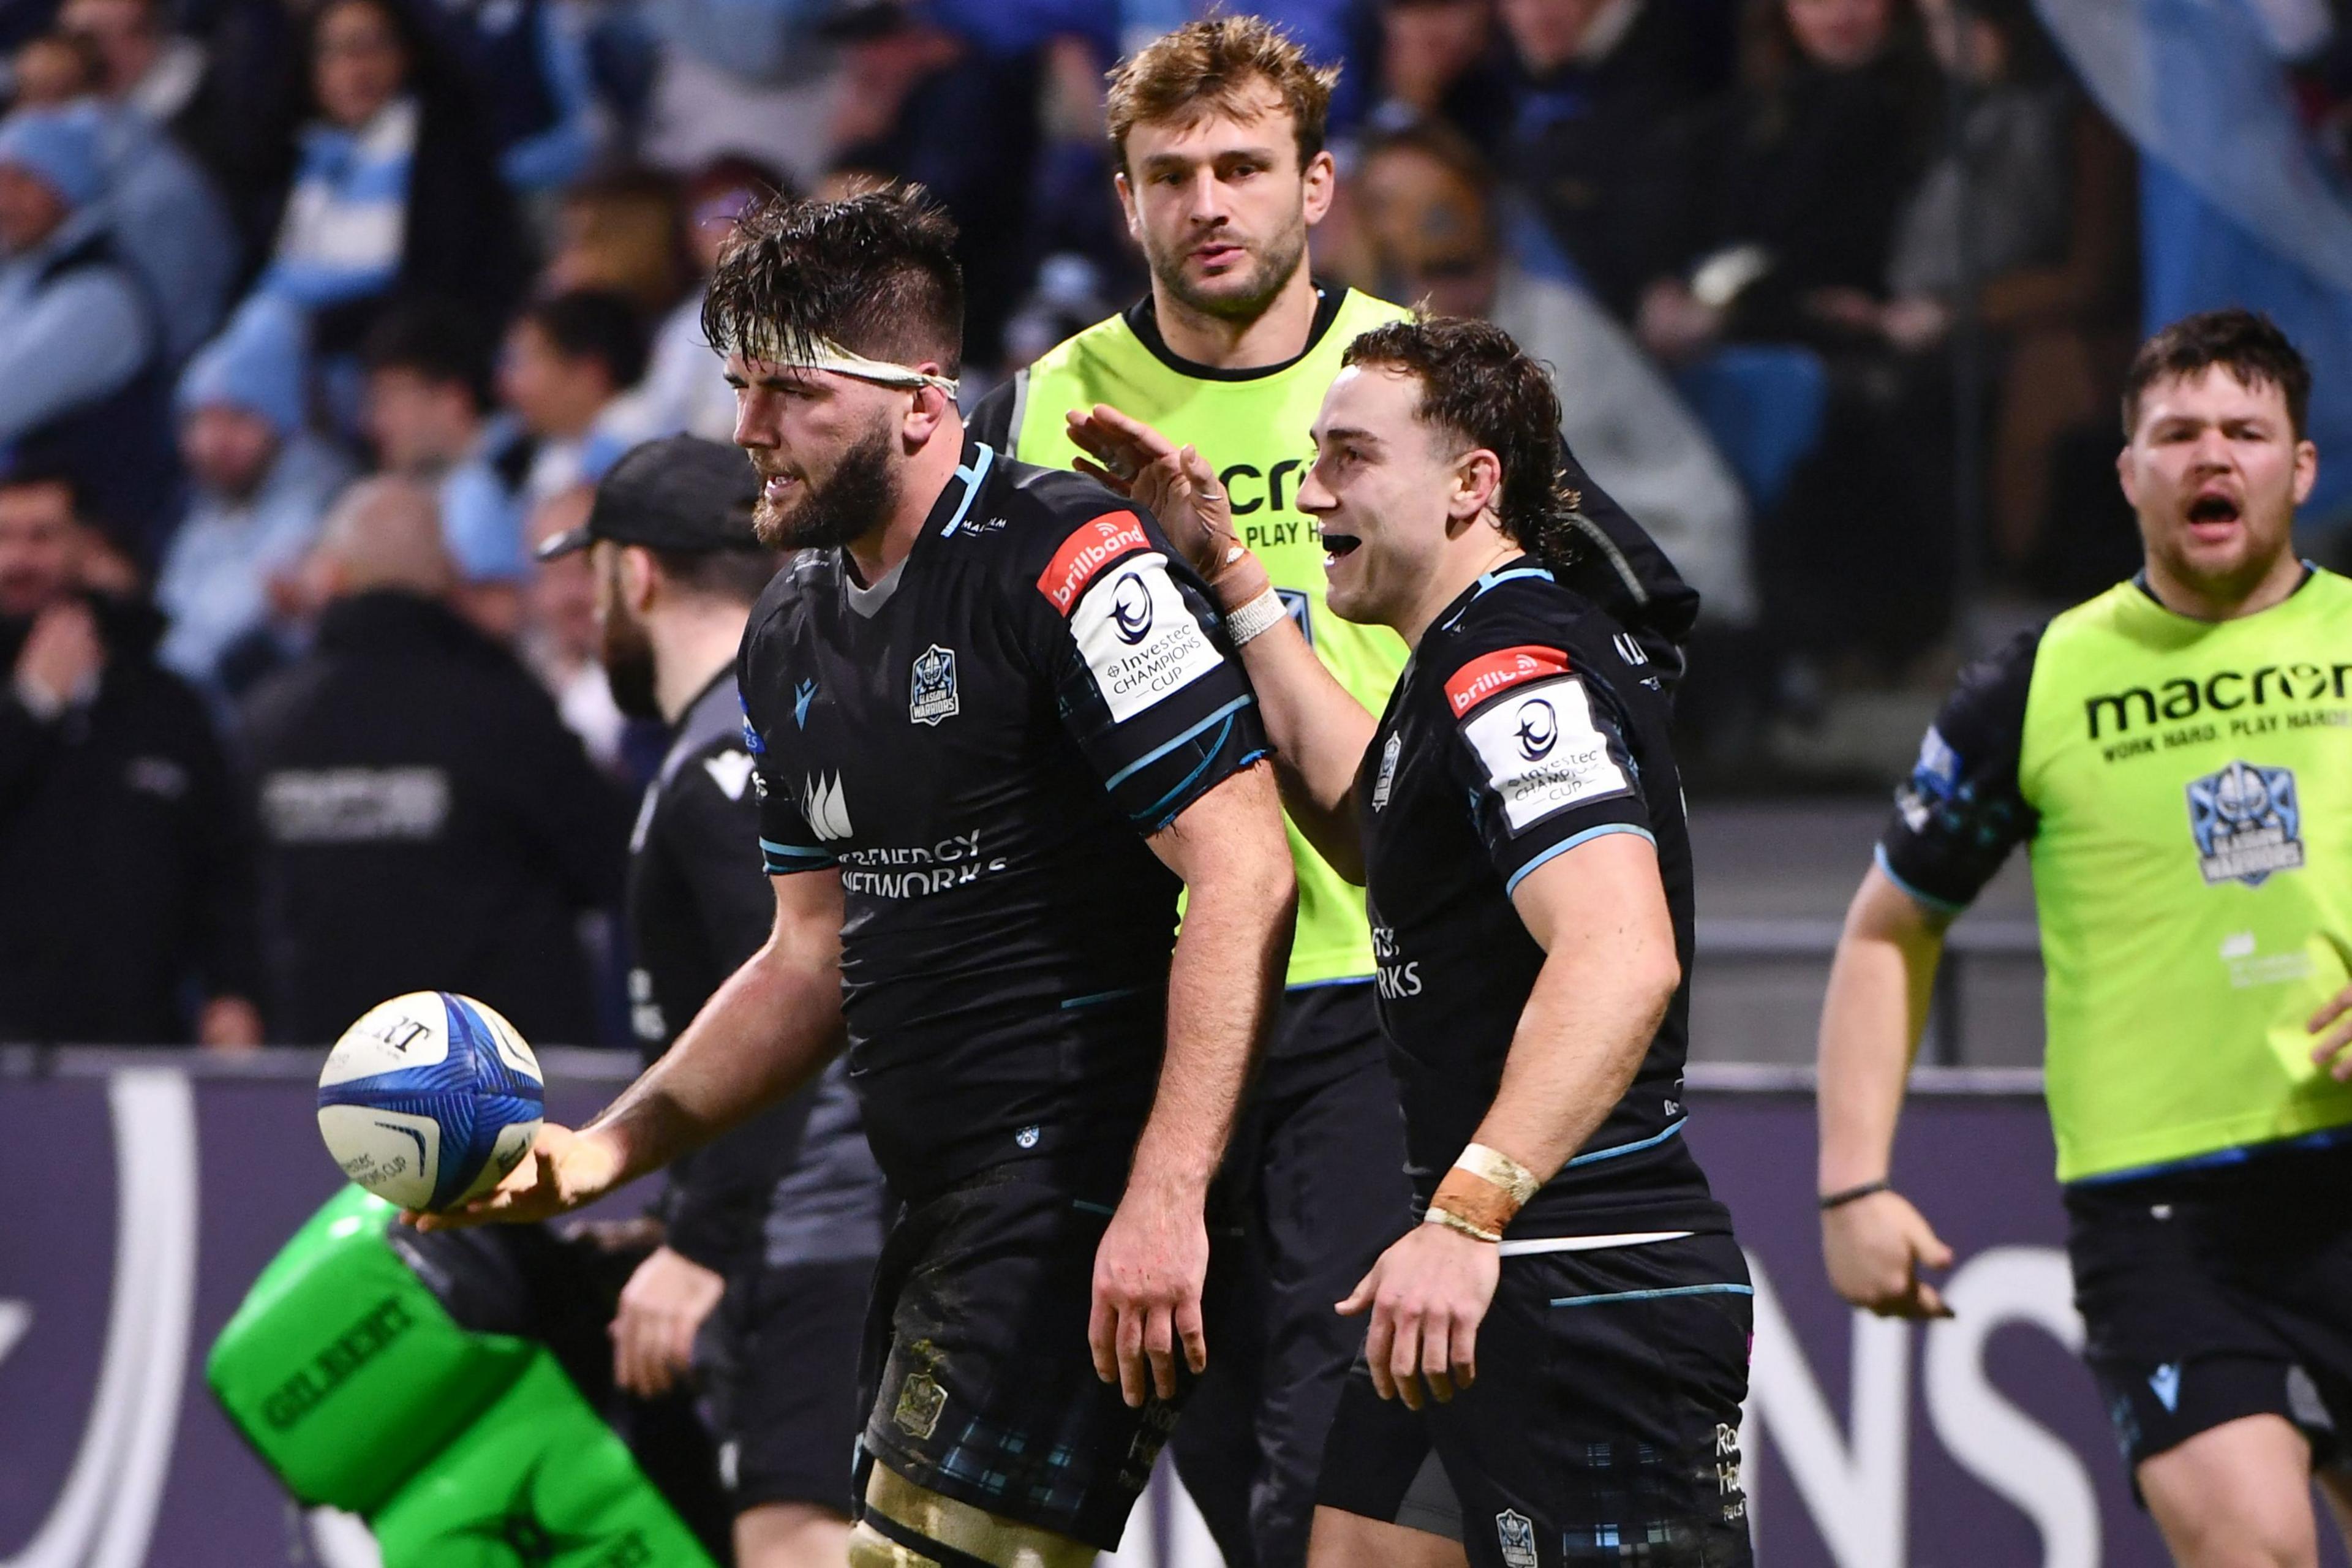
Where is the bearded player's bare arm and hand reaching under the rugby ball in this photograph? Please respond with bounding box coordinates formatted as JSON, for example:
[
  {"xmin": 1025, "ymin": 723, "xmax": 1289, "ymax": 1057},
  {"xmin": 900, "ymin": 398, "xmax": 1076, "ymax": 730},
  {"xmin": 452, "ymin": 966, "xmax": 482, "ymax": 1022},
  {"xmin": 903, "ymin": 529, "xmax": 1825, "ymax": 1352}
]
[{"xmin": 412, "ymin": 870, "xmax": 842, "ymax": 1229}]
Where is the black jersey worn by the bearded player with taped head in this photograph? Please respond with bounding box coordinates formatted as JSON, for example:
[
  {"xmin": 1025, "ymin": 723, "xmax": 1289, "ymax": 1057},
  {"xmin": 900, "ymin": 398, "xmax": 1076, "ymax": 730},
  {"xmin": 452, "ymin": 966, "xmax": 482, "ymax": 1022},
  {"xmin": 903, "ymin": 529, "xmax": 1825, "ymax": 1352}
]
[{"xmin": 739, "ymin": 442, "xmax": 1265, "ymax": 1199}]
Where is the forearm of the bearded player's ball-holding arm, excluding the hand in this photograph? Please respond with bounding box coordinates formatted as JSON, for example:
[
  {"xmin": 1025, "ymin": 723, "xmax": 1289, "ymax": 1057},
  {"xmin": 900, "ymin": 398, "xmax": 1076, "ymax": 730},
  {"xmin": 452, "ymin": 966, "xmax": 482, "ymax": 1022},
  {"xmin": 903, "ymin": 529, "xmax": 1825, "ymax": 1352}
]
[{"xmin": 581, "ymin": 950, "xmax": 842, "ymax": 1185}]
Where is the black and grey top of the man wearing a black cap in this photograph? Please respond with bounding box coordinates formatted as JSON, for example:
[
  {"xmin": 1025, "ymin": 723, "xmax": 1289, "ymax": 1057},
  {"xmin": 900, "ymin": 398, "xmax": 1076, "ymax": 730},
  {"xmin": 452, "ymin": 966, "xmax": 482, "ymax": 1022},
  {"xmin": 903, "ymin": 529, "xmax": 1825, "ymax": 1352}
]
[{"xmin": 628, "ymin": 670, "xmax": 882, "ymax": 1274}]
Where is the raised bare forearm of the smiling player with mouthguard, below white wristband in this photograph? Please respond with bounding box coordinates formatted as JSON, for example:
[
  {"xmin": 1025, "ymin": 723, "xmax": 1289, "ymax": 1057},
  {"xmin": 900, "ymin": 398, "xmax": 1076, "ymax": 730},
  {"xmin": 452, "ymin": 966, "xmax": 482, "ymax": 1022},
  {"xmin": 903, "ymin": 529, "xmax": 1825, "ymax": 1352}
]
[{"xmin": 1242, "ymin": 618, "xmax": 1374, "ymax": 881}]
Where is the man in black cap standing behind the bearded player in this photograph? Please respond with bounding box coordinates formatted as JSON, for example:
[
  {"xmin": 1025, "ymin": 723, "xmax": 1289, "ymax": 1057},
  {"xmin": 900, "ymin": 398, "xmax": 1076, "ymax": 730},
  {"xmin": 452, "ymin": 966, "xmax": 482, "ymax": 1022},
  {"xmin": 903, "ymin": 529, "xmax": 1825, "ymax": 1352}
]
[{"xmin": 538, "ymin": 435, "xmax": 882, "ymax": 1568}]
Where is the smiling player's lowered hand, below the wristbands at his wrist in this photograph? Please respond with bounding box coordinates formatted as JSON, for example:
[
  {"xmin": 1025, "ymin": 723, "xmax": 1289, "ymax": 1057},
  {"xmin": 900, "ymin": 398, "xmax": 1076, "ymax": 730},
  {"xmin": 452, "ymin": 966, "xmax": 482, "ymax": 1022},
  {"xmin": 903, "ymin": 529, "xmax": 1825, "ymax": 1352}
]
[{"xmin": 1338, "ymin": 1225, "xmax": 1503, "ymax": 1411}]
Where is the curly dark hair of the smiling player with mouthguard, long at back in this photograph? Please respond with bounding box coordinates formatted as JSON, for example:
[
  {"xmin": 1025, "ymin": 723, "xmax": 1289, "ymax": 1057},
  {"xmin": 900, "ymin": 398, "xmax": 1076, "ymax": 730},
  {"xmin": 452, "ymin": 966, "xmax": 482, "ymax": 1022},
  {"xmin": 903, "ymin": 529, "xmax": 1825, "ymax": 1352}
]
[{"xmin": 1341, "ymin": 312, "xmax": 1580, "ymax": 567}]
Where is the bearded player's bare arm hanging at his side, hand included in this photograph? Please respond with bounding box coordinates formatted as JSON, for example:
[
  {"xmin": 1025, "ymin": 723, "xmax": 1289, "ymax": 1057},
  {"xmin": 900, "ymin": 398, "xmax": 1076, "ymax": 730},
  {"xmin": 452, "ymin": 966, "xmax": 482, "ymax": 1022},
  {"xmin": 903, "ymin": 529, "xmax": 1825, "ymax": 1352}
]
[{"xmin": 1087, "ymin": 766, "xmax": 1298, "ymax": 1406}]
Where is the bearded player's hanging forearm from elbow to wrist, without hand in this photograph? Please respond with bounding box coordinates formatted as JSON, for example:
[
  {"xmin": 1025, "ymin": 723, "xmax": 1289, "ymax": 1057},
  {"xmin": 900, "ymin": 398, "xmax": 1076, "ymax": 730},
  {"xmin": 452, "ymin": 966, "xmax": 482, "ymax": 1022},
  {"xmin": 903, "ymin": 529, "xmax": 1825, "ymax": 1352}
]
[{"xmin": 1129, "ymin": 832, "xmax": 1298, "ymax": 1201}]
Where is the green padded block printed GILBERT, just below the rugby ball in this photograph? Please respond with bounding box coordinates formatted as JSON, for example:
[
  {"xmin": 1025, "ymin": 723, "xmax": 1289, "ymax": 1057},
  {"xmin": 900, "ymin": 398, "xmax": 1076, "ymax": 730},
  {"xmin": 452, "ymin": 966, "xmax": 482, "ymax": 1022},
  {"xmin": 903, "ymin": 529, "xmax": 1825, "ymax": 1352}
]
[{"xmin": 205, "ymin": 1187, "xmax": 537, "ymax": 1514}]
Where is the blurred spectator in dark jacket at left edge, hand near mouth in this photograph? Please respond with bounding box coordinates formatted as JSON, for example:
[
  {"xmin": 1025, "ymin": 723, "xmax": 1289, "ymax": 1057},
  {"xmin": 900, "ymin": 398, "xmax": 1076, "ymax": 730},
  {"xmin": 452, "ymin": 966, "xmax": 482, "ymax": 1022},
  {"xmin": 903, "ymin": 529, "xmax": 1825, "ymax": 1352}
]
[{"xmin": 0, "ymin": 475, "xmax": 261, "ymax": 1046}]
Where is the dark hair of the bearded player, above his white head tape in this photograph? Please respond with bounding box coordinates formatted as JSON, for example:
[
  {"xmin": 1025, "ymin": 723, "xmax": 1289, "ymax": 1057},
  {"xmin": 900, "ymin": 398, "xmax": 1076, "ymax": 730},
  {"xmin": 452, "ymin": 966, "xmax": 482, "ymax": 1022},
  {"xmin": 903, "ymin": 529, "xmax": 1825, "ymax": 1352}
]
[{"xmin": 703, "ymin": 186, "xmax": 964, "ymax": 376}]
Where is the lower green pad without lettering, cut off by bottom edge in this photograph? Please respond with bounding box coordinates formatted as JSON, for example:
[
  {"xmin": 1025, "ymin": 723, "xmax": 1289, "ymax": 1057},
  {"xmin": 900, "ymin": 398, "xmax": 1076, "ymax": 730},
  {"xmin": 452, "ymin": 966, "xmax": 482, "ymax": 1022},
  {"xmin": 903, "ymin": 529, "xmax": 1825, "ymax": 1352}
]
[{"xmin": 367, "ymin": 1349, "xmax": 710, "ymax": 1568}]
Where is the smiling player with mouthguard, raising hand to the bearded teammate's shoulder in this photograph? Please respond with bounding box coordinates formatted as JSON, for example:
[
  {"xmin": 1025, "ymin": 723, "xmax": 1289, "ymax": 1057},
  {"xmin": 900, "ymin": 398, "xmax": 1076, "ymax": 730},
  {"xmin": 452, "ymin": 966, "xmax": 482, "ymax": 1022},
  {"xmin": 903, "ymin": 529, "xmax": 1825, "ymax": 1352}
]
[{"xmin": 1087, "ymin": 320, "xmax": 1750, "ymax": 1568}]
